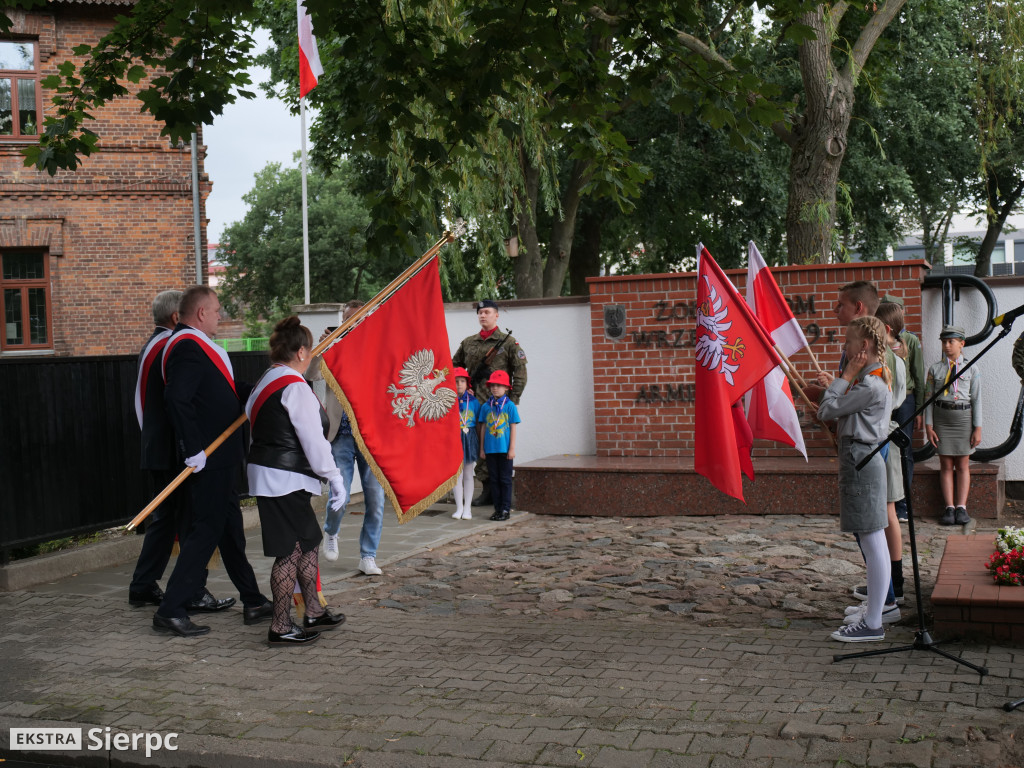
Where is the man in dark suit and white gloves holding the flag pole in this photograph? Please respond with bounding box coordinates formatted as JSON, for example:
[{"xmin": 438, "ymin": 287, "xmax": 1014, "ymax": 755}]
[{"xmin": 153, "ymin": 286, "xmax": 273, "ymax": 637}]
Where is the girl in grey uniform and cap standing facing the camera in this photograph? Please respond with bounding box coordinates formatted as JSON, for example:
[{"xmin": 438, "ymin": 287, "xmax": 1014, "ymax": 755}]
[{"xmin": 925, "ymin": 326, "xmax": 981, "ymax": 525}]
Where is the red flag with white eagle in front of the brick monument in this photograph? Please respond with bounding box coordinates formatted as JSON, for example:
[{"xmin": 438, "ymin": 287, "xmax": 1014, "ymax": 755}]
[{"xmin": 693, "ymin": 245, "xmax": 779, "ymax": 501}]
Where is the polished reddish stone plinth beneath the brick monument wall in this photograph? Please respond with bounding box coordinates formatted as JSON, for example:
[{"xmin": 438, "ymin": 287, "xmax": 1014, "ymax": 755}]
[{"xmin": 515, "ymin": 456, "xmax": 1006, "ymax": 519}]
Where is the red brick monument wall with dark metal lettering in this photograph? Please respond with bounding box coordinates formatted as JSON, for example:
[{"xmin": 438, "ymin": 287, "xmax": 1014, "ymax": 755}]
[{"xmin": 588, "ymin": 261, "xmax": 928, "ymax": 457}]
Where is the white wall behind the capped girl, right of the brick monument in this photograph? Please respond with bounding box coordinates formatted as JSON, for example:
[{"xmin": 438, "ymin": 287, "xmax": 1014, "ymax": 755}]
[{"xmin": 911, "ymin": 286, "xmax": 1024, "ymax": 481}]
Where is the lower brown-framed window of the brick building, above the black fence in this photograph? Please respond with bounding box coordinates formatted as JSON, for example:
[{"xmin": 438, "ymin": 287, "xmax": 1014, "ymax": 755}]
[{"xmin": 0, "ymin": 251, "xmax": 53, "ymax": 350}]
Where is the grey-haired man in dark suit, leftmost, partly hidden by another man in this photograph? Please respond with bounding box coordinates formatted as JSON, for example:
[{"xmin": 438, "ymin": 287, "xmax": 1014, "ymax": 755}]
[{"xmin": 128, "ymin": 291, "xmax": 234, "ymax": 611}]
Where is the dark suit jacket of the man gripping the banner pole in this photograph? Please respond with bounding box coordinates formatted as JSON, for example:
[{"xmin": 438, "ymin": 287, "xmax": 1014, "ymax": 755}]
[{"xmin": 164, "ymin": 323, "xmax": 245, "ymax": 469}]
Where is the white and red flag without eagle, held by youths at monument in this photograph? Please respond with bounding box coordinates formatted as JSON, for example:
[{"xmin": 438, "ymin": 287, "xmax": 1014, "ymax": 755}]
[{"xmin": 746, "ymin": 240, "xmax": 807, "ymax": 459}]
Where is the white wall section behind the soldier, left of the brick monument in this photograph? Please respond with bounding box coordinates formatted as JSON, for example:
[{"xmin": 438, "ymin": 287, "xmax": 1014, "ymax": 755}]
[{"xmin": 444, "ymin": 303, "xmax": 597, "ymax": 464}]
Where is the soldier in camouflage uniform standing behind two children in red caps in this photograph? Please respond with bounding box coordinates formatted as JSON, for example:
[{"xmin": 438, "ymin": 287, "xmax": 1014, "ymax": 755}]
[{"xmin": 452, "ymin": 299, "xmax": 526, "ymax": 507}]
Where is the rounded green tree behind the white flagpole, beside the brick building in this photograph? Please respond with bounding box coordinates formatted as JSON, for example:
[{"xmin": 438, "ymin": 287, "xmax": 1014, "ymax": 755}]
[{"xmin": 217, "ymin": 163, "xmax": 408, "ymax": 326}]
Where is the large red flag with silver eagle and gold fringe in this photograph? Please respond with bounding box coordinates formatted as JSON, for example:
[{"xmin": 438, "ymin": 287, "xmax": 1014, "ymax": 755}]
[{"xmin": 321, "ymin": 256, "xmax": 462, "ymax": 522}]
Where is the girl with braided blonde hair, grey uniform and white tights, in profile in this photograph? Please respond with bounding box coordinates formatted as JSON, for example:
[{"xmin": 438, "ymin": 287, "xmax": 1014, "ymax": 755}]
[{"xmin": 818, "ymin": 316, "xmax": 892, "ymax": 643}]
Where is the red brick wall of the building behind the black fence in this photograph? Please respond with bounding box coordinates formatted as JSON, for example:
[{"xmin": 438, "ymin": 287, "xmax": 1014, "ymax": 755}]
[{"xmin": 0, "ymin": 4, "xmax": 211, "ymax": 355}]
